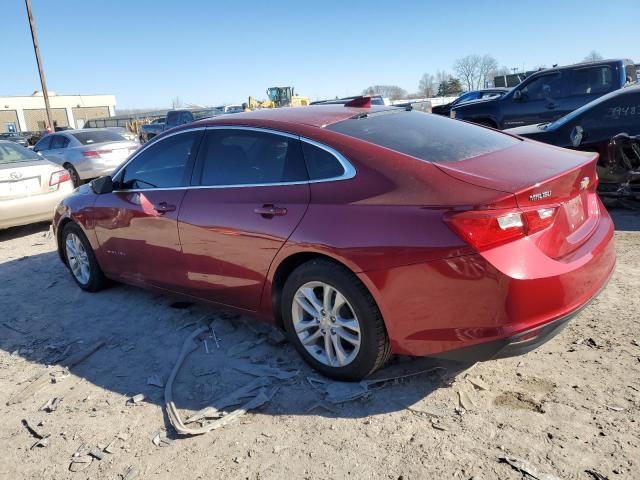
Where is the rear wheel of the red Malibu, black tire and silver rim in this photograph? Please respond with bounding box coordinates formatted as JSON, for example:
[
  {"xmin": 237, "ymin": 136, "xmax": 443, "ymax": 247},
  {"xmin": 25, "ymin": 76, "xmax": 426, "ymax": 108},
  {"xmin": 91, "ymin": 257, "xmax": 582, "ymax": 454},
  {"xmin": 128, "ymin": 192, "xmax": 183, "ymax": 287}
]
[{"xmin": 281, "ymin": 259, "xmax": 391, "ymax": 380}]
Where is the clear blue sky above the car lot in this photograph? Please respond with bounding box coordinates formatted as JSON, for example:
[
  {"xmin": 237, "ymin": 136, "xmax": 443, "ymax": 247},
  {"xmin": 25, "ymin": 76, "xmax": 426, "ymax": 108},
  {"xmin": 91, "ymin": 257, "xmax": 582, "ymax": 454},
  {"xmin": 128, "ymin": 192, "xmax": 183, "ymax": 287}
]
[{"xmin": 0, "ymin": 0, "xmax": 640, "ymax": 108}]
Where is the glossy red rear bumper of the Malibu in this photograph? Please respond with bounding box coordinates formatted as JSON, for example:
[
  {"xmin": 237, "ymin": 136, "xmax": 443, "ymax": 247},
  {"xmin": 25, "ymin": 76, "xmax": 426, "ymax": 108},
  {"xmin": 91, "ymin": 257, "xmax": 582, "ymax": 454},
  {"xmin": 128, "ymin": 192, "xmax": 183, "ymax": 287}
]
[{"xmin": 359, "ymin": 202, "xmax": 615, "ymax": 360}]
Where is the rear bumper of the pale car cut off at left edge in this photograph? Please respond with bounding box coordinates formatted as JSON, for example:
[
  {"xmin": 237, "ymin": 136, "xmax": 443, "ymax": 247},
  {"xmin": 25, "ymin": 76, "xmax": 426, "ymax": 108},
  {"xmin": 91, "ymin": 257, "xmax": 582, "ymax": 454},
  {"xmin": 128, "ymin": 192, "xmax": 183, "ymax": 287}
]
[{"xmin": 0, "ymin": 182, "xmax": 73, "ymax": 228}]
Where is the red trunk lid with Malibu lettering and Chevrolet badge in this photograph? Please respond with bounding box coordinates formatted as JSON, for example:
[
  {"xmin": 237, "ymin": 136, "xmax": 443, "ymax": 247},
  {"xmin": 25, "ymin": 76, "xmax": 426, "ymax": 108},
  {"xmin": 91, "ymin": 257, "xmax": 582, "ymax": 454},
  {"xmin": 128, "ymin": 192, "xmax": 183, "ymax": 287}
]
[{"xmin": 436, "ymin": 142, "xmax": 601, "ymax": 258}]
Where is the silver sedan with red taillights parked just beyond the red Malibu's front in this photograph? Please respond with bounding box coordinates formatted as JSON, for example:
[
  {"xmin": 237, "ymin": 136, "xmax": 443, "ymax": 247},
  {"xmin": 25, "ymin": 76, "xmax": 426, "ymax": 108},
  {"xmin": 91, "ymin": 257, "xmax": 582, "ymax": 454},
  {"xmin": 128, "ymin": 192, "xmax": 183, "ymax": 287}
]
[{"xmin": 33, "ymin": 128, "xmax": 139, "ymax": 187}]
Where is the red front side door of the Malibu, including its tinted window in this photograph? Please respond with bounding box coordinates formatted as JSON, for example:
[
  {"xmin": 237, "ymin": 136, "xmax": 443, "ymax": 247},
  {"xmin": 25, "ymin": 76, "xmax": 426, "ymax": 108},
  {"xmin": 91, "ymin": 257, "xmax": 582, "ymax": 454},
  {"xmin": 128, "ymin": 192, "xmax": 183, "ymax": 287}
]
[{"xmin": 95, "ymin": 130, "xmax": 202, "ymax": 289}]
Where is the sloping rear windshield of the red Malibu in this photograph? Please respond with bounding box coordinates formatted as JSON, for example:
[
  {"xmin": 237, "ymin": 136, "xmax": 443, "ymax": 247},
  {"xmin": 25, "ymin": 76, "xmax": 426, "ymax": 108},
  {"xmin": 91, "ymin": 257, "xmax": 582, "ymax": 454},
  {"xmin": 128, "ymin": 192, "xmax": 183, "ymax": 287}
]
[{"xmin": 327, "ymin": 111, "xmax": 520, "ymax": 163}]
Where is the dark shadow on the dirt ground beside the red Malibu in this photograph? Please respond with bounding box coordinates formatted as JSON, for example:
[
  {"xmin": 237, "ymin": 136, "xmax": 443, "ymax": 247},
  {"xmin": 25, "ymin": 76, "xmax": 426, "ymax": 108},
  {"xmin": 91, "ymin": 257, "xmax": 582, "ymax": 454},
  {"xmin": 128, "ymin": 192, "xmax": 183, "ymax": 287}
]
[{"xmin": 0, "ymin": 252, "xmax": 471, "ymax": 432}]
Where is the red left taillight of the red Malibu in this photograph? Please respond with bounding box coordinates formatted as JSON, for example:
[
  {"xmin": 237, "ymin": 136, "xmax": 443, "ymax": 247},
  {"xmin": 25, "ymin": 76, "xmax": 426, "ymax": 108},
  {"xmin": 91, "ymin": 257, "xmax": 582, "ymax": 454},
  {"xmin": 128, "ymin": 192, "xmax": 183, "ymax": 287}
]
[{"xmin": 444, "ymin": 207, "xmax": 558, "ymax": 250}]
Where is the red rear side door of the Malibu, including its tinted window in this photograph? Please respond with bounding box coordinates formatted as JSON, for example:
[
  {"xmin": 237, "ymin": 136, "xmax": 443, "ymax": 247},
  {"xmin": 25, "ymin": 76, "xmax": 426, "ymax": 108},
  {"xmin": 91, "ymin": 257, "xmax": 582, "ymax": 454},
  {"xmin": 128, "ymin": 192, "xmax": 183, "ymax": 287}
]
[{"xmin": 178, "ymin": 127, "xmax": 309, "ymax": 311}]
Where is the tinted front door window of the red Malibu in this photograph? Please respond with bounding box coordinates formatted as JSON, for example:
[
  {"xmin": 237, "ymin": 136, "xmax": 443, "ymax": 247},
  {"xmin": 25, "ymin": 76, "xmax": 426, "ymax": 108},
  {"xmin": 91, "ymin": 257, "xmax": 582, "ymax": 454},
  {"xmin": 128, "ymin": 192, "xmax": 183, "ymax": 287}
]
[{"xmin": 122, "ymin": 132, "xmax": 201, "ymax": 189}]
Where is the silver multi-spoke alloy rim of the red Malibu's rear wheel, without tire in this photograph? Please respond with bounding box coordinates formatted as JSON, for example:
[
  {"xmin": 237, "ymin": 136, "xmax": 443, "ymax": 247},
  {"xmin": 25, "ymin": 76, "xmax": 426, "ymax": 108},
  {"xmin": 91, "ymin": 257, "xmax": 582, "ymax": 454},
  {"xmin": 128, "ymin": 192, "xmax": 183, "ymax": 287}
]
[{"xmin": 291, "ymin": 282, "xmax": 361, "ymax": 367}]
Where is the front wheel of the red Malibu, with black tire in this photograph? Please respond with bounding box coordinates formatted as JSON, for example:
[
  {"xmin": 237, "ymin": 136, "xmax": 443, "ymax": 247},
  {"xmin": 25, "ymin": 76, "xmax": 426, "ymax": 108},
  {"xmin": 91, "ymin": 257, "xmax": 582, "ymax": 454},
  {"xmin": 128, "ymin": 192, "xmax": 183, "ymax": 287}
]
[{"xmin": 62, "ymin": 222, "xmax": 108, "ymax": 292}]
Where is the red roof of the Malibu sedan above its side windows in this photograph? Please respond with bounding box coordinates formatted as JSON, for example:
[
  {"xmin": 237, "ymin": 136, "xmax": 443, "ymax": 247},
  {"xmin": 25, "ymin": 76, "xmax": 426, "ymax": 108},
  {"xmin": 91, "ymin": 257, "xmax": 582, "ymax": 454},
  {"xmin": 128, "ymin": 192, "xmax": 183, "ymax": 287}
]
[{"xmin": 192, "ymin": 105, "xmax": 396, "ymax": 127}]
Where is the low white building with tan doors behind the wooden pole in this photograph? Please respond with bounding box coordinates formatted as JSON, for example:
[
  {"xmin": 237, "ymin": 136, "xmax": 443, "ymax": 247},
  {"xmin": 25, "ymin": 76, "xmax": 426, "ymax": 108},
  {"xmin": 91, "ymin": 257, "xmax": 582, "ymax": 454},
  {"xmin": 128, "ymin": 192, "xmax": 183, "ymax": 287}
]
[{"xmin": 0, "ymin": 92, "xmax": 116, "ymax": 132}]
